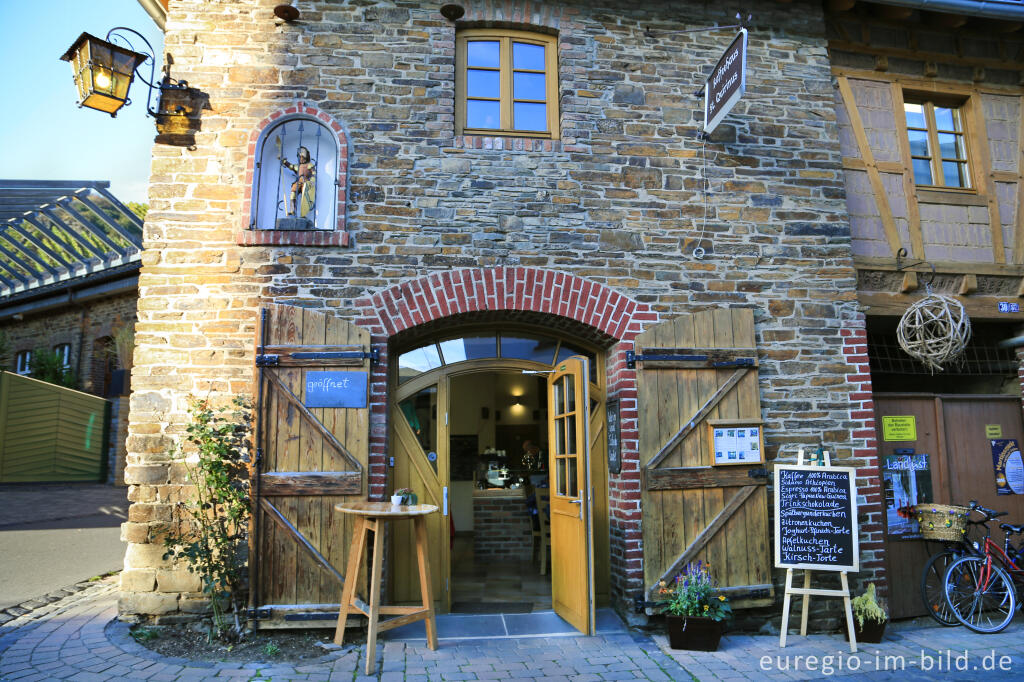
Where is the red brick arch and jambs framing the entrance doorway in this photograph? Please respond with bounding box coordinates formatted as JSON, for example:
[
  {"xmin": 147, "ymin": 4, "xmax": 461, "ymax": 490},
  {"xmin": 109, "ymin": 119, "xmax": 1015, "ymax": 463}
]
[{"xmin": 355, "ymin": 267, "xmax": 658, "ymax": 600}]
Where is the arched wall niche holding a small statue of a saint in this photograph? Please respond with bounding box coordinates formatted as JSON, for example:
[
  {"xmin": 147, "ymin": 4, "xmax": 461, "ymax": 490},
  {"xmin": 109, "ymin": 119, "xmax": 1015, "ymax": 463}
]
[{"xmin": 252, "ymin": 116, "xmax": 339, "ymax": 229}]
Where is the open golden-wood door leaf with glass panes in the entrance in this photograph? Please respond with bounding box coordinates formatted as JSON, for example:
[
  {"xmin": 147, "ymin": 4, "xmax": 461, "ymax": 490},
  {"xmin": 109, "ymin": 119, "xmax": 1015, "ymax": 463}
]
[{"xmin": 548, "ymin": 356, "xmax": 594, "ymax": 635}]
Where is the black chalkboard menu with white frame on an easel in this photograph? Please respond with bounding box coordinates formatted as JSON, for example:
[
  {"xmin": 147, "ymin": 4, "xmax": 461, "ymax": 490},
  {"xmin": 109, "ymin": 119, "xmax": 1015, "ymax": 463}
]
[{"xmin": 775, "ymin": 465, "xmax": 860, "ymax": 571}]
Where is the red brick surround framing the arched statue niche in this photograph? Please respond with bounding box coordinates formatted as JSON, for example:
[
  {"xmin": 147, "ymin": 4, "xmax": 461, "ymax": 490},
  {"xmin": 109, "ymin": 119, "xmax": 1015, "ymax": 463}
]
[{"xmin": 234, "ymin": 101, "xmax": 350, "ymax": 246}]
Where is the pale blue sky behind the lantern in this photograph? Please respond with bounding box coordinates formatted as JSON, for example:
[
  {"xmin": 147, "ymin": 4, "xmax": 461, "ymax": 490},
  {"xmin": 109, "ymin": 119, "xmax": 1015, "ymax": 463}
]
[{"xmin": 0, "ymin": 0, "xmax": 162, "ymax": 202}]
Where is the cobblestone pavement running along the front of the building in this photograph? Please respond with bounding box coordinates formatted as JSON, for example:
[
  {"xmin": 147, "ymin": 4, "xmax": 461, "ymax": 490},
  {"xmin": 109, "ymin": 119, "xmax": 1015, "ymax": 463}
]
[{"xmin": 0, "ymin": 578, "xmax": 1024, "ymax": 682}]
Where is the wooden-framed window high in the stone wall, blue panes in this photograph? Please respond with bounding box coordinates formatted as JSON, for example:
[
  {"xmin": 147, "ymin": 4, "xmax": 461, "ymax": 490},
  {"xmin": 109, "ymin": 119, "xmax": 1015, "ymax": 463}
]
[{"xmin": 456, "ymin": 29, "xmax": 558, "ymax": 138}]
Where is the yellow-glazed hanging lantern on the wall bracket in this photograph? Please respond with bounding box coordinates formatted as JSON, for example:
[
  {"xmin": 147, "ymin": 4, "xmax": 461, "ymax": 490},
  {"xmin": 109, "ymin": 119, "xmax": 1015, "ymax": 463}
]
[{"xmin": 60, "ymin": 33, "xmax": 148, "ymax": 117}]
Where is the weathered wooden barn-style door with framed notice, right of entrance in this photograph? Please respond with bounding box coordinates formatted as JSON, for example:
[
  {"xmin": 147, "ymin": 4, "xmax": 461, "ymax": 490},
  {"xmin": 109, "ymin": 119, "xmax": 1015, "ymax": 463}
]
[{"xmin": 634, "ymin": 309, "xmax": 772, "ymax": 607}]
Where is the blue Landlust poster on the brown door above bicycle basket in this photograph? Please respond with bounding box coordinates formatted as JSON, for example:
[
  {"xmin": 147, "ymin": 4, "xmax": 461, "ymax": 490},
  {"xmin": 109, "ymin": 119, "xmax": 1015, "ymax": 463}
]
[{"xmin": 882, "ymin": 450, "xmax": 934, "ymax": 540}]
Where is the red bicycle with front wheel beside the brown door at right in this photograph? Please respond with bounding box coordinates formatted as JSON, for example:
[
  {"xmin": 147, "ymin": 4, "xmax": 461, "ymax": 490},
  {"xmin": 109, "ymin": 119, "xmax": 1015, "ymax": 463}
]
[{"xmin": 942, "ymin": 503, "xmax": 1024, "ymax": 634}]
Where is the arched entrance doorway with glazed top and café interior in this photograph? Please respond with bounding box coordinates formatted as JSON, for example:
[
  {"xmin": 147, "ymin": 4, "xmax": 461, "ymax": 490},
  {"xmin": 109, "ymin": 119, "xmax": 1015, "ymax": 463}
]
[{"xmin": 388, "ymin": 329, "xmax": 610, "ymax": 632}]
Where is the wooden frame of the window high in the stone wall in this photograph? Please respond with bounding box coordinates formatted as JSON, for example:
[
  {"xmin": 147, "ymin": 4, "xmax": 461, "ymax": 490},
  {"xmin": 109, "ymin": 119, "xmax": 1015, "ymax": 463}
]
[{"xmin": 455, "ymin": 29, "xmax": 560, "ymax": 139}]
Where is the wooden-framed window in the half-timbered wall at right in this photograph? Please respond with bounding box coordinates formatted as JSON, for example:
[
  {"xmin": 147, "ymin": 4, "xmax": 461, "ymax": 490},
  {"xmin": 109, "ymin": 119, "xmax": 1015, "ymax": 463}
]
[{"xmin": 903, "ymin": 98, "xmax": 971, "ymax": 188}]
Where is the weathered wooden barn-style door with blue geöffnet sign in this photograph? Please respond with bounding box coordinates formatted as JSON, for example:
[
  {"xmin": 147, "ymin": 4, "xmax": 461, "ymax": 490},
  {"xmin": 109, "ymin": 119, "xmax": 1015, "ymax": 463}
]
[{"xmin": 250, "ymin": 305, "xmax": 370, "ymax": 628}]
